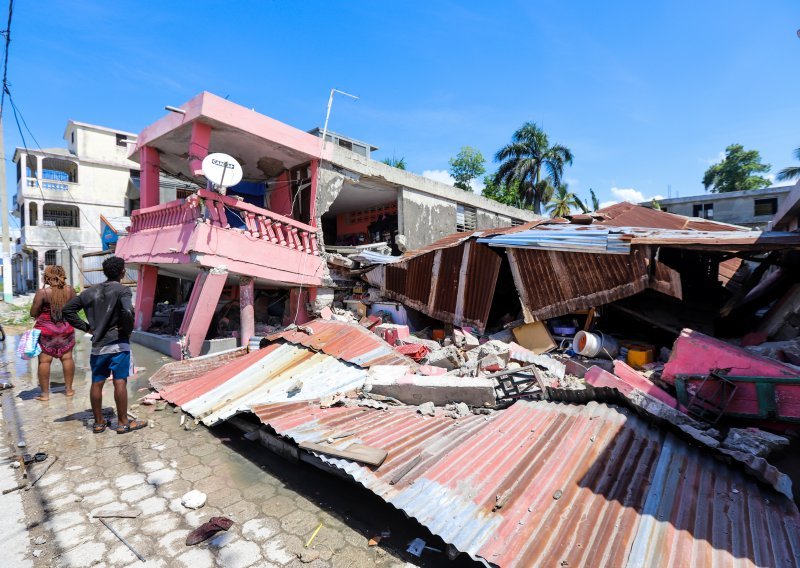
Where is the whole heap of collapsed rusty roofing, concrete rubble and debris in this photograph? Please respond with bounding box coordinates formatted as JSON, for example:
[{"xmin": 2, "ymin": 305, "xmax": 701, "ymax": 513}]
[{"xmin": 144, "ymin": 204, "xmax": 800, "ymax": 566}]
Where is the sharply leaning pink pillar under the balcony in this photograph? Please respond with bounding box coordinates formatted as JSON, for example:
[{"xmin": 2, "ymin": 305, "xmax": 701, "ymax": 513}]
[{"xmin": 179, "ymin": 268, "xmax": 228, "ymax": 357}]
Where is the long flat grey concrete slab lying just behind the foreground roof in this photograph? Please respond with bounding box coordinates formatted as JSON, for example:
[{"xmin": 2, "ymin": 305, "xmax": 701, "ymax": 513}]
[{"xmin": 364, "ymin": 375, "xmax": 495, "ymax": 406}]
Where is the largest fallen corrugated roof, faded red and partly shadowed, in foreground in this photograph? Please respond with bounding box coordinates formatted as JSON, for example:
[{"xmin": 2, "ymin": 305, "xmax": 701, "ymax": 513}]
[{"xmin": 254, "ymin": 401, "xmax": 800, "ymax": 568}]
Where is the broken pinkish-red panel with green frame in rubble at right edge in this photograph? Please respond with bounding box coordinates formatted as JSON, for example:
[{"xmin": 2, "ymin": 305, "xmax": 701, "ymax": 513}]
[{"xmin": 661, "ymin": 329, "xmax": 800, "ymax": 420}]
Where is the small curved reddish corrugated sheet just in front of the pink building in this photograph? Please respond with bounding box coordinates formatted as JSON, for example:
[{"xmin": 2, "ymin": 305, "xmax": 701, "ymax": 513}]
[{"xmin": 267, "ymin": 320, "xmax": 417, "ymax": 369}]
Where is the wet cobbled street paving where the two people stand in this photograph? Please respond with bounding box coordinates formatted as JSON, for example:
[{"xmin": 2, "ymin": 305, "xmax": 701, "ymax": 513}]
[{"xmin": 0, "ymin": 338, "xmax": 454, "ymax": 568}]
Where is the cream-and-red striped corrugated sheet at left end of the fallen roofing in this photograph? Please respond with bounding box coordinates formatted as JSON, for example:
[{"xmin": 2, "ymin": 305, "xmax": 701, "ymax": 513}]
[{"xmin": 160, "ymin": 343, "xmax": 367, "ymax": 426}]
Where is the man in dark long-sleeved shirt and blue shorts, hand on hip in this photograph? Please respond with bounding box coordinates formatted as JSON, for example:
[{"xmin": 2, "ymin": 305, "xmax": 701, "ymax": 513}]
[{"xmin": 62, "ymin": 256, "xmax": 147, "ymax": 434}]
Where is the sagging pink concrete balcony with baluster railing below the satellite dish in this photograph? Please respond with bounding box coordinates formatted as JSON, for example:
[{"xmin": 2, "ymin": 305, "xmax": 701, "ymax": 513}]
[{"xmin": 116, "ymin": 190, "xmax": 324, "ymax": 286}]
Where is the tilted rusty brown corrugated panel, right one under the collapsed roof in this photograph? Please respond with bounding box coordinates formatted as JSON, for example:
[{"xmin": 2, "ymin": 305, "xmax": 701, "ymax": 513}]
[{"xmin": 506, "ymin": 247, "xmax": 648, "ymax": 322}]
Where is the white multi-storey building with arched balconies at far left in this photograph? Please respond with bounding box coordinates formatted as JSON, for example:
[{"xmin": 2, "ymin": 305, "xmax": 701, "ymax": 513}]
[{"xmin": 12, "ymin": 120, "xmax": 139, "ymax": 293}]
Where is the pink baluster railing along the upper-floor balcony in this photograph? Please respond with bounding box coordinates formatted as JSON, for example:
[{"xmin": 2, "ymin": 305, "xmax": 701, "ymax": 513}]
[{"xmin": 129, "ymin": 189, "xmax": 319, "ymax": 256}]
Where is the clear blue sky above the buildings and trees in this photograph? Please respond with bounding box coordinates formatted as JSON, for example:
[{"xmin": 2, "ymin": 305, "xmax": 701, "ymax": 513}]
[{"xmin": 5, "ymin": 0, "xmax": 800, "ymax": 221}]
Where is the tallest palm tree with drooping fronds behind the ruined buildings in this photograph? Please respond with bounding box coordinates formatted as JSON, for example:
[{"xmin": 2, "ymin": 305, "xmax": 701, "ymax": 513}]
[{"xmin": 494, "ymin": 122, "xmax": 572, "ymax": 215}]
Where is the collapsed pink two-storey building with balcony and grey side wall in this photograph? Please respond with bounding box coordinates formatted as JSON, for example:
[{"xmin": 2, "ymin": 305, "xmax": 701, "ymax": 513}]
[{"xmin": 116, "ymin": 92, "xmax": 535, "ymax": 358}]
